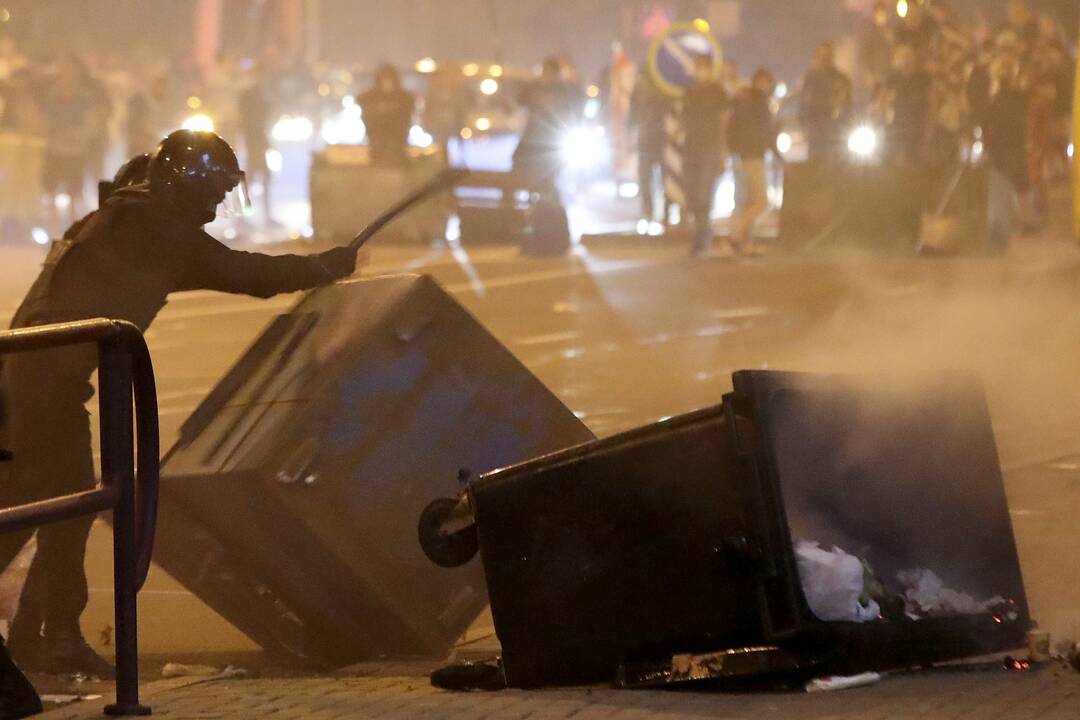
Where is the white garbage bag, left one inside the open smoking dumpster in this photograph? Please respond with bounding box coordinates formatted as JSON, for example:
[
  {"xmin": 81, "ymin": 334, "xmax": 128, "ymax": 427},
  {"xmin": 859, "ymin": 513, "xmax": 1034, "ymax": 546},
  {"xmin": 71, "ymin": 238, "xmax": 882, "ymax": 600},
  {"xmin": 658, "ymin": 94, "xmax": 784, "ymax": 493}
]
[{"xmin": 795, "ymin": 540, "xmax": 881, "ymax": 623}]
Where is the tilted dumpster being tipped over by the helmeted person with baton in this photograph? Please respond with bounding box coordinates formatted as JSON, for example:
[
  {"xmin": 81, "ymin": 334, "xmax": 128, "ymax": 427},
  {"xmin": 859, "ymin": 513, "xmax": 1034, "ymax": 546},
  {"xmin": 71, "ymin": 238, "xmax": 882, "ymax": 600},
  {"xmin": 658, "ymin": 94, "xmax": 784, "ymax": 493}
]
[{"xmin": 154, "ymin": 275, "xmax": 593, "ymax": 667}]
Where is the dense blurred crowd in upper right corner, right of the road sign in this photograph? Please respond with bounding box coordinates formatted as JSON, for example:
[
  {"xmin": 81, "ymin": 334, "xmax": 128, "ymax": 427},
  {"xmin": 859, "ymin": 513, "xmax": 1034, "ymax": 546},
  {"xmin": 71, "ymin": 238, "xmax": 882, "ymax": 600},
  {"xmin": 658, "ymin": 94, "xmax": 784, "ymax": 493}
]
[{"xmin": 851, "ymin": 0, "xmax": 1076, "ymax": 236}]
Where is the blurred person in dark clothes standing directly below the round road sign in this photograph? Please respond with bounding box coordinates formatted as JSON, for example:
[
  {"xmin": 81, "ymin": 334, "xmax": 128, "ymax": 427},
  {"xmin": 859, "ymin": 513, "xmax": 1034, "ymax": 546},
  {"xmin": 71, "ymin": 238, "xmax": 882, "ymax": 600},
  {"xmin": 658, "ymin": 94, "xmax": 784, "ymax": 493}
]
[{"xmin": 683, "ymin": 55, "xmax": 731, "ymax": 257}]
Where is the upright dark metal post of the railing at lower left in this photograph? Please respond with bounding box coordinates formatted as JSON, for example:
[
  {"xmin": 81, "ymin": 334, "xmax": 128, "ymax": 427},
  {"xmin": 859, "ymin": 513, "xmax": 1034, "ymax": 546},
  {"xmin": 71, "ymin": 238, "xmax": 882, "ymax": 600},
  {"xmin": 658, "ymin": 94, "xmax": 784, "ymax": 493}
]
[{"xmin": 98, "ymin": 340, "xmax": 150, "ymax": 716}]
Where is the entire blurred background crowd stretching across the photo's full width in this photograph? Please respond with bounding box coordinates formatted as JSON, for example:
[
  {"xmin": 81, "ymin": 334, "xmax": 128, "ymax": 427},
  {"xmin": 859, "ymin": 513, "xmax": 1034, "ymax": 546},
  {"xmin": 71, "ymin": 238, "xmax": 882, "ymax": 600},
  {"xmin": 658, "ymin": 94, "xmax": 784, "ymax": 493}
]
[{"xmin": 0, "ymin": 0, "xmax": 1075, "ymax": 253}]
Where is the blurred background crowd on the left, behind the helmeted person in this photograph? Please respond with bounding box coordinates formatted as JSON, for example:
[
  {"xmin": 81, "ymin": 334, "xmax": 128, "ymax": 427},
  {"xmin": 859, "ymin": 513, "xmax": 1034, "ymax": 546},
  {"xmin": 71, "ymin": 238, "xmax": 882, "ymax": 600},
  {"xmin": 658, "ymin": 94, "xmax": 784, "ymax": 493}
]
[{"xmin": 0, "ymin": 36, "xmax": 318, "ymax": 228}]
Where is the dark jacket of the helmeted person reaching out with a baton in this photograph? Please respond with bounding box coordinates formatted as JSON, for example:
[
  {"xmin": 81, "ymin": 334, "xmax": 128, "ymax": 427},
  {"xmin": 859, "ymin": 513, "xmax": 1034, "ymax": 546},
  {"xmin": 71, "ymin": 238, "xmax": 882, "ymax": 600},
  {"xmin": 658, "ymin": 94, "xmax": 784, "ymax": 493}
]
[{"xmin": 6, "ymin": 186, "xmax": 355, "ymax": 398}]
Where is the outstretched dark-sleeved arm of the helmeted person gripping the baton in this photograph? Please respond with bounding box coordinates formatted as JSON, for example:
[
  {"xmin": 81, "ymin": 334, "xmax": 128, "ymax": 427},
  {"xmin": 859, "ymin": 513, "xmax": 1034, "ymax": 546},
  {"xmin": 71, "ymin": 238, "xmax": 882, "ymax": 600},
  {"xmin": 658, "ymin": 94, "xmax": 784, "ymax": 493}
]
[{"xmin": 171, "ymin": 231, "xmax": 356, "ymax": 298}]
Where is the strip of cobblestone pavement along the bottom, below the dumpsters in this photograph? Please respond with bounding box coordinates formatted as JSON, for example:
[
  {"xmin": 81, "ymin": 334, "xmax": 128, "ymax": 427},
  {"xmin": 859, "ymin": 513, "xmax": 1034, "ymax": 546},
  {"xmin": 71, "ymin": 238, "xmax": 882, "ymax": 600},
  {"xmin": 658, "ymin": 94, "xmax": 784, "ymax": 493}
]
[{"xmin": 41, "ymin": 665, "xmax": 1080, "ymax": 720}]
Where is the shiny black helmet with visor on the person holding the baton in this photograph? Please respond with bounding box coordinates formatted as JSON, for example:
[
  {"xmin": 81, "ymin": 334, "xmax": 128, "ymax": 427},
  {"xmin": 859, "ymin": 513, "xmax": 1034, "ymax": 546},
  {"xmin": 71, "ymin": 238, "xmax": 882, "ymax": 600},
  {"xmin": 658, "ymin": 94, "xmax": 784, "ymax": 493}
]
[{"xmin": 147, "ymin": 130, "xmax": 247, "ymax": 225}]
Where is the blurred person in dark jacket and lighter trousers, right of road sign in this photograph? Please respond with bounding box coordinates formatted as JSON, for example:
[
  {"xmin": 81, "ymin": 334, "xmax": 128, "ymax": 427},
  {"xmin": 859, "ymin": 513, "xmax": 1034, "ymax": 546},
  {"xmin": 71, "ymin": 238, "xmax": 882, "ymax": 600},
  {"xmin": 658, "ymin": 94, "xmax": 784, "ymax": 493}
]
[{"xmin": 728, "ymin": 68, "xmax": 780, "ymax": 254}]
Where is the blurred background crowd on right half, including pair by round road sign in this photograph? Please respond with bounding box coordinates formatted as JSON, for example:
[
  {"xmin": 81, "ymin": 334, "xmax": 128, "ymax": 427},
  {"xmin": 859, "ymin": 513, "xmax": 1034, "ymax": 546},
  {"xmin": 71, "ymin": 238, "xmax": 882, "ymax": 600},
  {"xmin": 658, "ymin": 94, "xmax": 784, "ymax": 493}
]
[{"xmin": 631, "ymin": 0, "xmax": 1076, "ymax": 255}]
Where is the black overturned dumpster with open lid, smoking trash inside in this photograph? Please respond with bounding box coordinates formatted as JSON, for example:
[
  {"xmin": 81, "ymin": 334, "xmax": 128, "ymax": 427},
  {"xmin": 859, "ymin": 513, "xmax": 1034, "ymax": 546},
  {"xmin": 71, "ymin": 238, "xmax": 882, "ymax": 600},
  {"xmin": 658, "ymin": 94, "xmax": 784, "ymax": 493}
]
[{"xmin": 421, "ymin": 371, "xmax": 1029, "ymax": 687}]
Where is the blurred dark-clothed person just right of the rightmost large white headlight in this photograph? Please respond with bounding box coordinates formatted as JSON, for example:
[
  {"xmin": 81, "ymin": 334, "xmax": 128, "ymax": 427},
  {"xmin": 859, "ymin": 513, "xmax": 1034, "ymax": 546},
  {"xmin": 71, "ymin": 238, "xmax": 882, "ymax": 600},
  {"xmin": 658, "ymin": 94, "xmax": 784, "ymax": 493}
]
[{"xmin": 888, "ymin": 45, "xmax": 933, "ymax": 165}]
